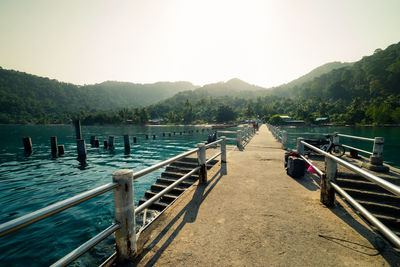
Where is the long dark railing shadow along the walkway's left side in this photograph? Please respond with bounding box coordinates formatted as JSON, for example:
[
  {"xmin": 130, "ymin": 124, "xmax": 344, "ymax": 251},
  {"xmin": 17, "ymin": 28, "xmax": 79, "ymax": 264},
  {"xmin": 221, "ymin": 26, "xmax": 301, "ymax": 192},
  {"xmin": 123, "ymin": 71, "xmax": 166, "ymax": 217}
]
[{"xmin": 135, "ymin": 167, "xmax": 224, "ymax": 266}]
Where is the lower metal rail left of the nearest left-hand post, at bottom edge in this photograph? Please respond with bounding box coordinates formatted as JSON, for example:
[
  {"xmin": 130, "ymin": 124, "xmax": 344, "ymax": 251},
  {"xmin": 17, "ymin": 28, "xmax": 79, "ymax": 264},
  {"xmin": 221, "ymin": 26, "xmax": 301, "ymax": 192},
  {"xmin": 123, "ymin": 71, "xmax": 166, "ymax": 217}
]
[{"xmin": 51, "ymin": 223, "xmax": 120, "ymax": 267}]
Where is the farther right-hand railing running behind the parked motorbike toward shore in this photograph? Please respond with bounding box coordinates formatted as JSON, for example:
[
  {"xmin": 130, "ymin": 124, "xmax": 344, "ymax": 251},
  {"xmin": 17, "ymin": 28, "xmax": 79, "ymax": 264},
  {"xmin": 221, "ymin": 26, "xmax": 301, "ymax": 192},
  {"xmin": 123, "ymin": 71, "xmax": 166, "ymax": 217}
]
[{"xmin": 267, "ymin": 124, "xmax": 384, "ymax": 165}]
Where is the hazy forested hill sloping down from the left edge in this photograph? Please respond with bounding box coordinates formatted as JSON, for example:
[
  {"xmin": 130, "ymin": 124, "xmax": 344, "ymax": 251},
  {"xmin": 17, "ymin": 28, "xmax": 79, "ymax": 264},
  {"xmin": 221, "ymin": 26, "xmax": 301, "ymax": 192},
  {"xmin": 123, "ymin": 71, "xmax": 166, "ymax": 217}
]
[{"xmin": 0, "ymin": 67, "xmax": 196, "ymax": 123}]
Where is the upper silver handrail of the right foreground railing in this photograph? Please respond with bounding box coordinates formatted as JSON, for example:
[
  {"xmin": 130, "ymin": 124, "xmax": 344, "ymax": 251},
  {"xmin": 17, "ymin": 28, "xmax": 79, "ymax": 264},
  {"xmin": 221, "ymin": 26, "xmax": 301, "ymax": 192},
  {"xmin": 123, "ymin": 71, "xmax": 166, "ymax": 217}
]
[{"xmin": 301, "ymin": 141, "xmax": 400, "ymax": 196}]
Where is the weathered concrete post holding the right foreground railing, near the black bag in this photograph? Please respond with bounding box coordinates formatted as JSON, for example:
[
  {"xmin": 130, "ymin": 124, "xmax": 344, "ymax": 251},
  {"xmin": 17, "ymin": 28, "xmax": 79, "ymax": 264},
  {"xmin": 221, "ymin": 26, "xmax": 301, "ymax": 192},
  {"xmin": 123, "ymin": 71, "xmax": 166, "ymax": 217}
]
[{"xmin": 320, "ymin": 157, "xmax": 337, "ymax": 207}]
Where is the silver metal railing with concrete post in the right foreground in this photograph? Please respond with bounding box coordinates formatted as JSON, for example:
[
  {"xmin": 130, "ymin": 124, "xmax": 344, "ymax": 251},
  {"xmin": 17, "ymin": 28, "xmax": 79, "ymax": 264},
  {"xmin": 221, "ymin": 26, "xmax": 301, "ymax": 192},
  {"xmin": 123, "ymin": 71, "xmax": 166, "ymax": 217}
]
[{"xmin": 297, "ymin": 138, "xmax": 400, "ymax": 248}]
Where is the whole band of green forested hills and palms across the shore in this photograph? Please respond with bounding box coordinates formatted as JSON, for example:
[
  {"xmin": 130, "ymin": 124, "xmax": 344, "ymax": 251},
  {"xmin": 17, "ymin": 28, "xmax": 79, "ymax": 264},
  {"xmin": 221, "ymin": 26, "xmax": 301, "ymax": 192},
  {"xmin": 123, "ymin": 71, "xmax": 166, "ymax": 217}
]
[{"xmin": 0, "ymin": 43, "xmax": 400, "ymax": 124}]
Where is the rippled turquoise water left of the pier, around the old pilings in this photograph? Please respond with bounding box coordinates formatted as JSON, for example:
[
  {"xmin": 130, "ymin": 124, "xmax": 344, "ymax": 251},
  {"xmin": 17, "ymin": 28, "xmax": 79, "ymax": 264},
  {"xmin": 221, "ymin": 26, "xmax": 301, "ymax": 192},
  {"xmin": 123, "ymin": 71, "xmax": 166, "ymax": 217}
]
[{"xmin": 0, "ymin": 125, "xmax": 219, "ymax": 266}]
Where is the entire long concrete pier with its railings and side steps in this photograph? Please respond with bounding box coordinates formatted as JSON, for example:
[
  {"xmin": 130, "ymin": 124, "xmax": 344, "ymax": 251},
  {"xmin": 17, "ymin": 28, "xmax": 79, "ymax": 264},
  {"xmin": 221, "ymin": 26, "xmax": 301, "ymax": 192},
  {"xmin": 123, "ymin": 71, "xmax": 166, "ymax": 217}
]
[{"xmin": 0, "ymin": 125, "xmax": 400, "ymax": 266}]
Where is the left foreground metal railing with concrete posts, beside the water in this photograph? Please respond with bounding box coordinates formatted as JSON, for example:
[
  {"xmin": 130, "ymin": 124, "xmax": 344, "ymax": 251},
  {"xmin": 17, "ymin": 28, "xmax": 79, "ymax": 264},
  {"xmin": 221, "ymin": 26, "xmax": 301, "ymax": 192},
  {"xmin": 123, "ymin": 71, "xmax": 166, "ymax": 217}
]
[{"xmin": 0, "ymin": 136, "xmax": 226, "ymax": 266}]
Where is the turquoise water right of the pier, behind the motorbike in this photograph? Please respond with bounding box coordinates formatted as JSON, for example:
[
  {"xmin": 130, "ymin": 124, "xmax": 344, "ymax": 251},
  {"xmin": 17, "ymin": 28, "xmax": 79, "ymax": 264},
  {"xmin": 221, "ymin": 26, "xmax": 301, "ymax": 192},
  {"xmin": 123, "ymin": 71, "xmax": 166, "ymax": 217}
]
[{"xmin": 285, "ymin": 126, "xmax": 400, "ymax": 168}]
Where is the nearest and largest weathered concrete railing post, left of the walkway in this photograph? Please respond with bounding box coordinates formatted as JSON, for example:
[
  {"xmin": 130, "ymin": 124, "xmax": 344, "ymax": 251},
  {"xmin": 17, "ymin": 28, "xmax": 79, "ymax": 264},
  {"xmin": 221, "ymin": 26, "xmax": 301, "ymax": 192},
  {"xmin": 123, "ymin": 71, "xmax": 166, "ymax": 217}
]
[{"xmin": 112, "ymin": 170, "xmax": 136, "ymax": 263}]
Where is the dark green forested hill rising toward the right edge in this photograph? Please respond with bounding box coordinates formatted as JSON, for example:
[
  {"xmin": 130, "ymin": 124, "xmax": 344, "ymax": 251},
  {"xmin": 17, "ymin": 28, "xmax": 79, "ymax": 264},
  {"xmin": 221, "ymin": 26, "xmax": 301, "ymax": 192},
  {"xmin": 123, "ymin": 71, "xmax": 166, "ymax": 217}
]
[{"xmin": 276, "ymin": 43, "xmax": 400, "ymax": 100}]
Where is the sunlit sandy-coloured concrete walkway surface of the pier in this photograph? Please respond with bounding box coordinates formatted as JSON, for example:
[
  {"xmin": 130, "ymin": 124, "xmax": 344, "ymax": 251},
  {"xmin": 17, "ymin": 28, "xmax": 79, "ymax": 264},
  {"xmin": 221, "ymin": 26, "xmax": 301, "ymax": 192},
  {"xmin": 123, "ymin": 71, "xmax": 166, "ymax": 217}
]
[{"xmin": 135, "ymin": 125, "xmax": 400, "ymax": 266}]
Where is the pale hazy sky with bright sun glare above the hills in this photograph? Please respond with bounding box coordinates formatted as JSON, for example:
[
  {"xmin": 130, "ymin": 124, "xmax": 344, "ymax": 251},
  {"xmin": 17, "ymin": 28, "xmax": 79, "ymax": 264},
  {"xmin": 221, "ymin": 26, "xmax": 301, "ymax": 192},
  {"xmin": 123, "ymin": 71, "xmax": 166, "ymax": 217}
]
[{"xmin": 0, "ymin": 0, "xmax": 400, "ymax": 87}]
